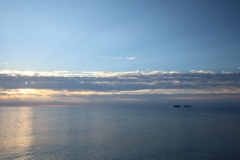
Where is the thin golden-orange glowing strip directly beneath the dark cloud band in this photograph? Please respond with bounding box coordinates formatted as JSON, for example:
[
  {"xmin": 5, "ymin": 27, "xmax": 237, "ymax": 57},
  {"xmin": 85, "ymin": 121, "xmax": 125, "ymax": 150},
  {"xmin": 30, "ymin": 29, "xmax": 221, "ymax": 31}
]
[{"xmin": 0, "ymin": 89, "xmax": 240, "ymax": 98}]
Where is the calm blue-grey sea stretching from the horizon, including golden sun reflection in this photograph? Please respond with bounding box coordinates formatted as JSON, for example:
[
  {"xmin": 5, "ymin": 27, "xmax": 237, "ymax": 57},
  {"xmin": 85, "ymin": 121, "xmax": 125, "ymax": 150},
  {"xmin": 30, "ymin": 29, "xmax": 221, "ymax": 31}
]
[{"xmin": 0, "ymin": 107, "xmax": 240, "ymax": 160}]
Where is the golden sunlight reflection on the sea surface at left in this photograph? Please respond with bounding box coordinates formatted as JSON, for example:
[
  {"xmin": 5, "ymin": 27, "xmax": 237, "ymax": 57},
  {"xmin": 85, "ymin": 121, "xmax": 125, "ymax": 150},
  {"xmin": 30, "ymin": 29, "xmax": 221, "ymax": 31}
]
[{"xmin": 0, "ymin": 107, "xmax": 33, "ymax": 159}]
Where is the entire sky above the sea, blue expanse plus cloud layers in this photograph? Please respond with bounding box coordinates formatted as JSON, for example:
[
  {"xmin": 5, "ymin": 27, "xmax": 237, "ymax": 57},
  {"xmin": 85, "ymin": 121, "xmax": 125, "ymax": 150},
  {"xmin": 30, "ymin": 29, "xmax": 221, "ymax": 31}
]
[{"xmin": 0, "ymin": 0, "xmax": 240, "ymax": 106}]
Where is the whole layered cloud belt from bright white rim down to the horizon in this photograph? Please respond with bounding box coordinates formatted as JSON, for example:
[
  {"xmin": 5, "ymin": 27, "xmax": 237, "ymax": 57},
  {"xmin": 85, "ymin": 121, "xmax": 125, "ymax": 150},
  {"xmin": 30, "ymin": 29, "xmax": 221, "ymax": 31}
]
[{"xmin": 0, "ymin": 70, "xmax": 240, "ymax": 105}]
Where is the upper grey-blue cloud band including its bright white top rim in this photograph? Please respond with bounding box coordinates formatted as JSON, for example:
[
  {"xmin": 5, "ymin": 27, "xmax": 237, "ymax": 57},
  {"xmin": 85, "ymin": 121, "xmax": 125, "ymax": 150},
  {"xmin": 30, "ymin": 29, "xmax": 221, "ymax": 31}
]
[{"xmin": 0, "ymin": 70, "xmax": 240, "ymax": 91}]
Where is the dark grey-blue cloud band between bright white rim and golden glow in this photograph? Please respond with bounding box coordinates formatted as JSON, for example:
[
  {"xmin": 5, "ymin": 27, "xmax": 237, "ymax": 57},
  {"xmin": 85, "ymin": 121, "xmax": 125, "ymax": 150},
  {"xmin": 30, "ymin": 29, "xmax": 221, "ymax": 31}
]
[{"xmin": 0, "ymin": 73, "xmax": 240, "ymax": 92}]
